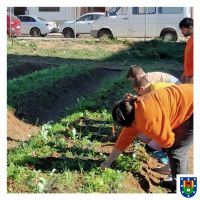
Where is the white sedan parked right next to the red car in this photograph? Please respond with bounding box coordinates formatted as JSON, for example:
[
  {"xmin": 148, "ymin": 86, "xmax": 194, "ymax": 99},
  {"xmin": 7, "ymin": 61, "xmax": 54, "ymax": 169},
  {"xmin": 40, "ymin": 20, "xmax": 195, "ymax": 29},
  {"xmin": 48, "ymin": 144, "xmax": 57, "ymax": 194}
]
[{"xmin": 17, "ymin": 15, "xmax": 57, "ymax": 37}]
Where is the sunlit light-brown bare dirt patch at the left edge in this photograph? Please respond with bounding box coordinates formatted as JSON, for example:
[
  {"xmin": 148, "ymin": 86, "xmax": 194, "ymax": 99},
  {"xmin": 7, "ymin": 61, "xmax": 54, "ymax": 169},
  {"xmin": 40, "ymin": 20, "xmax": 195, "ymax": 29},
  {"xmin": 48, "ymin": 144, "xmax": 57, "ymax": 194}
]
[{"xmin": 7, "ymin": 111, "xmax": 40, "ymax": 149}]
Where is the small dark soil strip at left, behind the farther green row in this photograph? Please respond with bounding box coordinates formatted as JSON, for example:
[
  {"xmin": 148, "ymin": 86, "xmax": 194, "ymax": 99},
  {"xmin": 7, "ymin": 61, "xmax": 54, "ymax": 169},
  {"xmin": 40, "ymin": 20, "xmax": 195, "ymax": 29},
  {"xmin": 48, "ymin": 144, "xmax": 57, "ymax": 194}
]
[{"xmin": 7, "ymin": 62, "xmax": 55, "ymax": 79}]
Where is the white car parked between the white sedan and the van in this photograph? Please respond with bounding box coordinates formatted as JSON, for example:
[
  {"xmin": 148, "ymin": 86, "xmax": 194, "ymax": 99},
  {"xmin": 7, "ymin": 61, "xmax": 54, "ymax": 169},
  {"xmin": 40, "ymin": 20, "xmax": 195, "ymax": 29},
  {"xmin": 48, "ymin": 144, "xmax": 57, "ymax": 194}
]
[{"xmin": 58, "ymin": 12, "xmax": 105, "ymax": 38}]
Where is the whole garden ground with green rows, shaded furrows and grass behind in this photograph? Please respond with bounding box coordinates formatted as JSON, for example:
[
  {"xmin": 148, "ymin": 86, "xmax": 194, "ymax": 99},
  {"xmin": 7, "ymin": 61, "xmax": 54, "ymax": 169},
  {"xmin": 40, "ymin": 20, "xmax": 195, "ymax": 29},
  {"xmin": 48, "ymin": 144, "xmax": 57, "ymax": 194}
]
[{"xmin": 7, "ymin": 40, "xmax": 191, "ymax": 193}]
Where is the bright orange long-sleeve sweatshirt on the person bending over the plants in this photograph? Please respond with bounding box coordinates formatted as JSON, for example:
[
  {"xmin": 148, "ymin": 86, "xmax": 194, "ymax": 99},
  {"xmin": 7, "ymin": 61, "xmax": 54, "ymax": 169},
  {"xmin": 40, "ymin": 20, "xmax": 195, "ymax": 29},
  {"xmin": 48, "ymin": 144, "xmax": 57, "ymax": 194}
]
[{"xmin": 115, "ymin": 84, "xmax": 193, "ymax": 151}]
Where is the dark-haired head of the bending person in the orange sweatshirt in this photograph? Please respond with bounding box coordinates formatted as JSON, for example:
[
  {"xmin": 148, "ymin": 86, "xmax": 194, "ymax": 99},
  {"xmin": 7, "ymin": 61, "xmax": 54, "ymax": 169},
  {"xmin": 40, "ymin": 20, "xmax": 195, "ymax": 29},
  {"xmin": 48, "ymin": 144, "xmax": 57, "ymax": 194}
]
[{"xmin": 112, "ymin": 98, "xmax": 135, "ymax": 127}]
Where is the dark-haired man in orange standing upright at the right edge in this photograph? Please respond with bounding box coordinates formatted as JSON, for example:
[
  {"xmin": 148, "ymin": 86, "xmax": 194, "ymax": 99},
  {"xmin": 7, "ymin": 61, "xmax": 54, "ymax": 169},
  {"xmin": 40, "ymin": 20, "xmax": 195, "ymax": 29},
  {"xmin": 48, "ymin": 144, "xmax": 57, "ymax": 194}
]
[{"xmin": 179, "ymin": 17, "xmax": 193, "ymax": 83}]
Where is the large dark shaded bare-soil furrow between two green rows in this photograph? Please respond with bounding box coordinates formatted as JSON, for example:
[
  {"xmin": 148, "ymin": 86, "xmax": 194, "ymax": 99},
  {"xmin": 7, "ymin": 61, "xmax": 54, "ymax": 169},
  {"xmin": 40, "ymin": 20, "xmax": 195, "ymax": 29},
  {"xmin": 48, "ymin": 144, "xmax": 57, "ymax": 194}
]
[{"xmin": 12, "ymin": 68, "xmax": 120, "ymax": 124}]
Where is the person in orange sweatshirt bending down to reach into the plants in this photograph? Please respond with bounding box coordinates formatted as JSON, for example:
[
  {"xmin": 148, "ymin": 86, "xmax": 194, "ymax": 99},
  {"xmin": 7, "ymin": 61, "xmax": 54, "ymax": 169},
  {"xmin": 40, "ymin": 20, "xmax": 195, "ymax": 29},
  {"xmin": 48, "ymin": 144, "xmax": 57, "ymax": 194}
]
[{"xmin": 101, "ymin": 84, "xmax": 193, "ymax": 190}]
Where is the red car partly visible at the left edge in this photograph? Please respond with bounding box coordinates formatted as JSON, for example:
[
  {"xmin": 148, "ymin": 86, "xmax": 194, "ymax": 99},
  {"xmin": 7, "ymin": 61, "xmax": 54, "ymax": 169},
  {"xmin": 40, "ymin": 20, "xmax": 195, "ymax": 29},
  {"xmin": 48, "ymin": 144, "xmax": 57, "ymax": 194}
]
[{"xmin": 7, "ymin": 12, "xmax": 21, "ymax": 36}]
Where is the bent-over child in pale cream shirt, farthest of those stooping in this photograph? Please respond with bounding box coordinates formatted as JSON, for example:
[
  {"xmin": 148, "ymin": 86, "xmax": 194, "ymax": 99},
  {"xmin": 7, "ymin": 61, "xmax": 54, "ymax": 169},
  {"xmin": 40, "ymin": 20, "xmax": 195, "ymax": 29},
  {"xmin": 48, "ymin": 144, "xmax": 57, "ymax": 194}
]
[{"xmin": 127, "ymin": 65, "xmax": 180, "ymax": 84}]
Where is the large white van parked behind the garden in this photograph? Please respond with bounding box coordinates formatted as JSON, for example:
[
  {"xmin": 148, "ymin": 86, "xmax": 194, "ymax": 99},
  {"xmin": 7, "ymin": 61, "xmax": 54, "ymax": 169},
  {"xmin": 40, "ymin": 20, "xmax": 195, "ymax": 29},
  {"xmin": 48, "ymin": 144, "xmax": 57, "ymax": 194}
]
[{"xmin": 90, "ymin": 7, "xmax": 191, "ymax": 41}]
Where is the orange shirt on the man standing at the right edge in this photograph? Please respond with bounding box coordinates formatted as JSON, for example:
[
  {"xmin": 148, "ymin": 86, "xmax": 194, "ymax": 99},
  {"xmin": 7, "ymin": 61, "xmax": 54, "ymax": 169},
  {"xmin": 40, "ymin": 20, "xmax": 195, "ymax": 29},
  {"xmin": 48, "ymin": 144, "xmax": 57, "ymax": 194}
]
[{"xmin": 184, "ymin": 35, "xmax": 193, "ymax": 77}]
